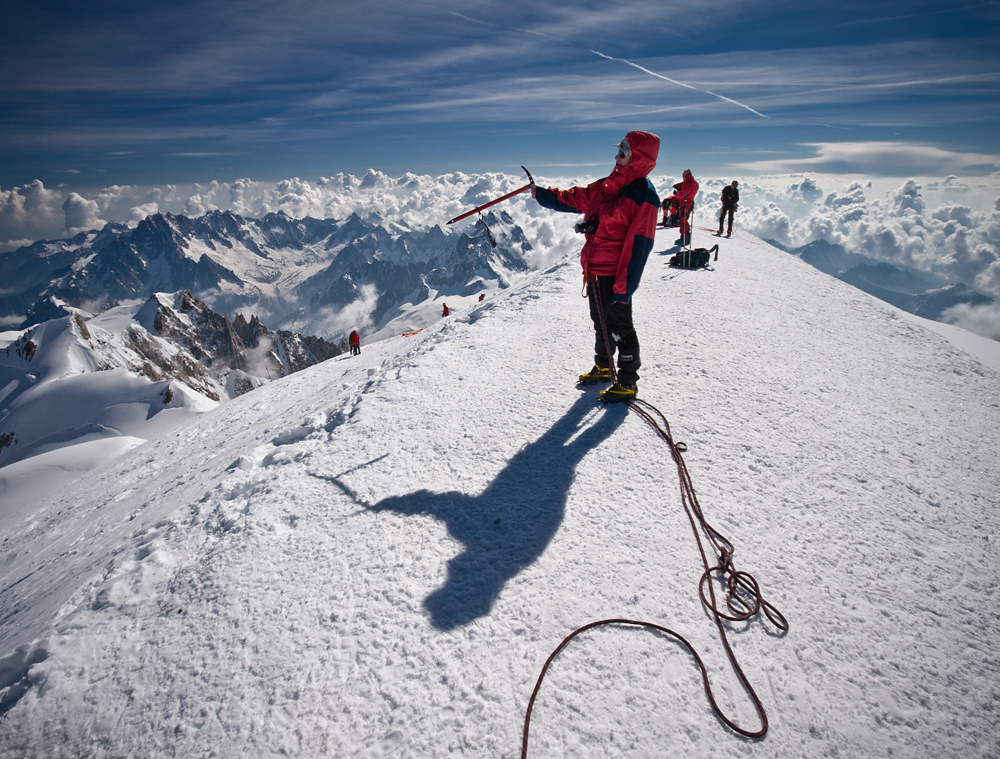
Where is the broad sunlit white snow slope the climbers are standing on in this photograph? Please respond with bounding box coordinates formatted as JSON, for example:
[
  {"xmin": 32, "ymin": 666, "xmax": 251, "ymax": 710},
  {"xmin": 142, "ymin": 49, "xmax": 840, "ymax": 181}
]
[{"xmin": 0, "ymin": 230, "xmax": 1000, "ymax": 759}]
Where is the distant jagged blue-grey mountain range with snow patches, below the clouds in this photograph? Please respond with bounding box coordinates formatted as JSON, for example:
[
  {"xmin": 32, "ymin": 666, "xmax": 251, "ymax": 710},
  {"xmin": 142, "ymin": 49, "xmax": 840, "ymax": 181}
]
[{"xmin": 0, "ymin": 206, "xmax": 531, "ymax": 340}]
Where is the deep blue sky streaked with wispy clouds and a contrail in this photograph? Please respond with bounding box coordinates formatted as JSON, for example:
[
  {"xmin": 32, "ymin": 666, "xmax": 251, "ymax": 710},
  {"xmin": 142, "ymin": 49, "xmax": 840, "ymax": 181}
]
[{"xmin": 0, "ymin": 0, "xmax": 1000, "ymax": 189}]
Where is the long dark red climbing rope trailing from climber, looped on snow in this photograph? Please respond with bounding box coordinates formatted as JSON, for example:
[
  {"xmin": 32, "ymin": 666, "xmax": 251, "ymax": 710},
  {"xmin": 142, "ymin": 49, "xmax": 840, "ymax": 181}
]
[{"xmin": 521, "ymin": 280, "xmax": 788, "ymax": 759}]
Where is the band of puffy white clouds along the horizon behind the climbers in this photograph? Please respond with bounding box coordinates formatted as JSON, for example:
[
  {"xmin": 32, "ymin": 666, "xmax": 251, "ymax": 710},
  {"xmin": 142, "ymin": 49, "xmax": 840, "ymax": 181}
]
[{"xmin": 0, "ymin": 170, "xmax": 1000, "ymax": 339}]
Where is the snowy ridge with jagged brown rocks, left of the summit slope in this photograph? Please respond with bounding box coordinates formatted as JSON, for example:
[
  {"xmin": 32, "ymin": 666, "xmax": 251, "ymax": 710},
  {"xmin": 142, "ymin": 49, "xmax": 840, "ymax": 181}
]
[{"xmin": 0, "ymin": 291, "xmax": 347, "ymax": 520}]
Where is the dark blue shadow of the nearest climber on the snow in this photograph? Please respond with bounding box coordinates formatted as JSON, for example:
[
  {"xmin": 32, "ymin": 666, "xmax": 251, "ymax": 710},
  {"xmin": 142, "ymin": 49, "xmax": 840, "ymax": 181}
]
[{"xmin": 367, "ymin": 394, "xmax": 628, "ymax": 630}]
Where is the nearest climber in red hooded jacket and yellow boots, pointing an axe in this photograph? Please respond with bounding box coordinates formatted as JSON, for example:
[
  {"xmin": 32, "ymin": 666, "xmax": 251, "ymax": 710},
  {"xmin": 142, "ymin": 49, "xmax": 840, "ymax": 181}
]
[{"xmin": 532, "ymin": 131, "xmax": 660, "ymax": 403}]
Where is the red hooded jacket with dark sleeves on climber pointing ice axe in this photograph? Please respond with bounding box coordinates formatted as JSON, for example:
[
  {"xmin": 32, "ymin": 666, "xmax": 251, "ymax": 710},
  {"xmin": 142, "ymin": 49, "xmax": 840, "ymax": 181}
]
[{"xmin": 535, "ymin": 132, "xmax": 660, "ymax": 303}]
